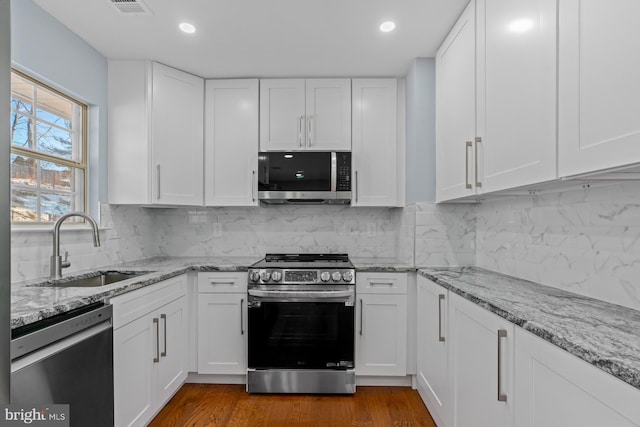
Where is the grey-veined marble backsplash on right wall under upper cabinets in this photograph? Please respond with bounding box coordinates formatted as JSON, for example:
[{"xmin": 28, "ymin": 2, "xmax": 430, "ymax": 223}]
[{"xmin": 476, "ymin": 181, "xmax": 640, "ymax": 309}]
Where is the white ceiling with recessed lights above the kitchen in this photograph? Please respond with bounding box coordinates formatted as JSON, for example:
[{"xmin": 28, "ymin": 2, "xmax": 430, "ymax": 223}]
[{"xmin": 34, "ymin": 0, "xmax": 468, "ymax": 78}]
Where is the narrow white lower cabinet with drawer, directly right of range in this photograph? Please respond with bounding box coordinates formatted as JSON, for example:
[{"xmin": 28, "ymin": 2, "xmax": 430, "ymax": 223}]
[{"xmin": 356, "ymin": 273, "xmax": 407, "ymax": 376}]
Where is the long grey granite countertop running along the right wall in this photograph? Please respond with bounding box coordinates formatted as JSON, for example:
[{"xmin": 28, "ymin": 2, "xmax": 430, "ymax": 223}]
[{"xmin": 418, "ymin": 267, "xmax": 640, "ymax": 388}]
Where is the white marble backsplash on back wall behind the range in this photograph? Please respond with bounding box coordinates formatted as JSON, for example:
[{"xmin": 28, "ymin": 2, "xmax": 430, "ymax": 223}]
[{"xmin": 146, "ymin": 205, "xmax": 412, "ymax": 262}]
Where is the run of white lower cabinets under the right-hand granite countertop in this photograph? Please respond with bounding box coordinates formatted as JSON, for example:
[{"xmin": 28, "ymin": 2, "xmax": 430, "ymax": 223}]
[{"xmin": 416, "ymin": 276, "xmax": 640, "ymax": 427}]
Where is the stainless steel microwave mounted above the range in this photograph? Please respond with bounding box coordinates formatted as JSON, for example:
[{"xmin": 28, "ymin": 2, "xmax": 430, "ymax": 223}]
[{"xmin": 258, "ymin": 151, "xmax": 351, "ymax": 204}]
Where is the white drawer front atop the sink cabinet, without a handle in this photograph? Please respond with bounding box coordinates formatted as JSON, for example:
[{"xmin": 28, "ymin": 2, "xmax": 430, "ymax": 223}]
[{"xmin": 111, "ymin": 274, "xmax": 187, "ymax": 329}]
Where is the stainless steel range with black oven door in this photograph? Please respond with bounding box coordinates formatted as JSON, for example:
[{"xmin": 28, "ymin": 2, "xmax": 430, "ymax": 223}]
[{"xmin": 247, "ymin": 254, "xmax": 356, "ymax": 394}]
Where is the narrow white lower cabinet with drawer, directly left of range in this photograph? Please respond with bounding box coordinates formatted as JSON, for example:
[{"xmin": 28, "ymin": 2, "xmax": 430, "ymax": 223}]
[{"xmin": 198, "ymin": 272, "xmax": 247, "ymax": 375}]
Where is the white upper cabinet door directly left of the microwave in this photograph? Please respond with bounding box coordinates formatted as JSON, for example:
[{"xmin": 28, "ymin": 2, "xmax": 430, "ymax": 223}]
[{"xmin": 204, "ymin": 79, "xmax": 259, "ymax": 206}]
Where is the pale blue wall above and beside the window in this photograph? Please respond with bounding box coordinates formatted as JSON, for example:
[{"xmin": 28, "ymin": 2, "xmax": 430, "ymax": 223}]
[{"xmin": 11, "ymin": 0, "xmax": 107, "ymax": 209}]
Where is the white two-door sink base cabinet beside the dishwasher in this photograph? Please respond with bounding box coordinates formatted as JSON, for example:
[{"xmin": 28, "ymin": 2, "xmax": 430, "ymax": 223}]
[{"xmin": 111, "ymin": 275, "xmax": 187, "ymax": 426}]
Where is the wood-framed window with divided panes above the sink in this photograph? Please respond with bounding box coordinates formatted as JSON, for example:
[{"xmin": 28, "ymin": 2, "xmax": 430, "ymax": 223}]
[{"xmin": 10, "ymin": 70, "xmax": 87, "ymax": 224}]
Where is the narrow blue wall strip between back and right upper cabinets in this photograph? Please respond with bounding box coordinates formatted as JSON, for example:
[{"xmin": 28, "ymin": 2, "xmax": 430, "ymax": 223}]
[{"xmin": 406, "ymin": 58, "xmax": 436, "ymax": 204}]
